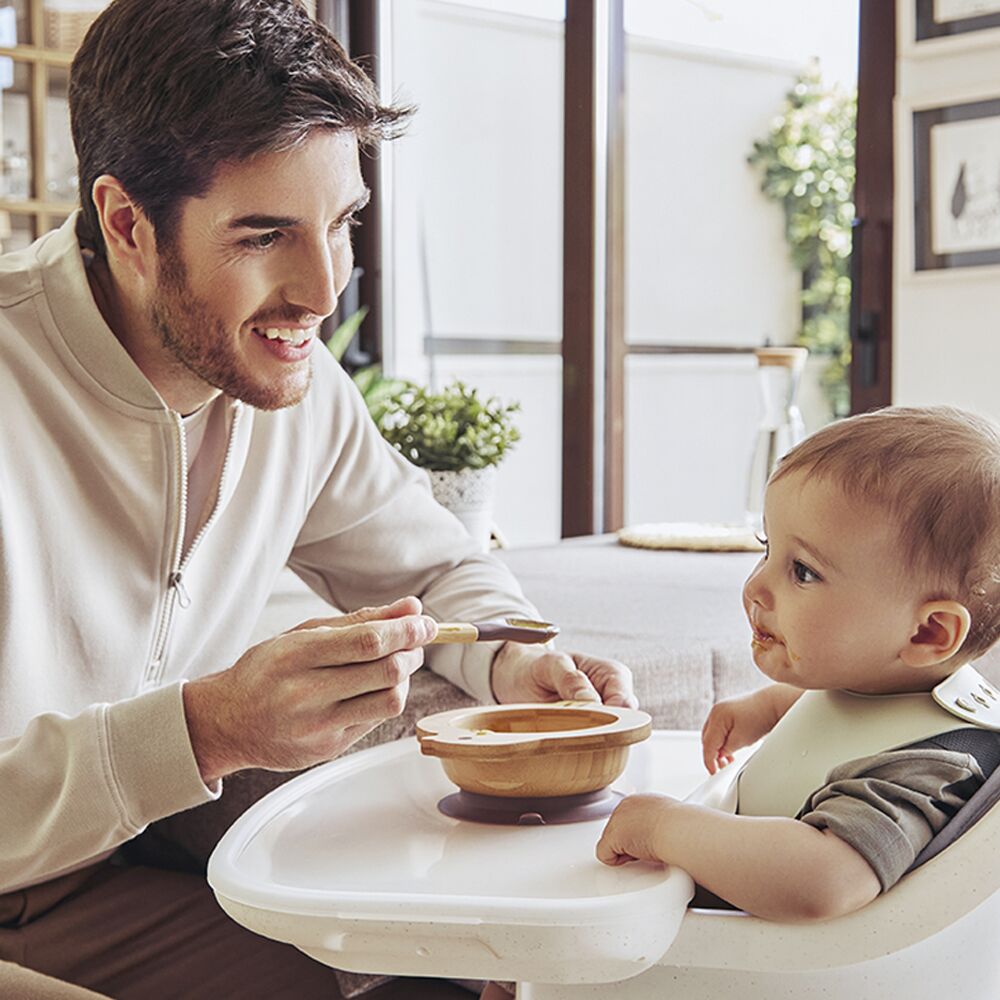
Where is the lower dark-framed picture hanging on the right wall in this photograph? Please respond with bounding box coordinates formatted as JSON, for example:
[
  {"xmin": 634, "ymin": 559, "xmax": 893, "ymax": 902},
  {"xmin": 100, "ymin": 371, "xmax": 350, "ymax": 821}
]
[{"xmin": 913, "ymin": 97, "xmax": 1000, "ymax": 271}]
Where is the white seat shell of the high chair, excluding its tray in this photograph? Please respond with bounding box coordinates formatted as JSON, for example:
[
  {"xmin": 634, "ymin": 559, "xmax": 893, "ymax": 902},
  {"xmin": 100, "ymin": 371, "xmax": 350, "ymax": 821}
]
[{"xmin": 518, "ymin": 767, "xmax": 1000, "ymax": 1000}]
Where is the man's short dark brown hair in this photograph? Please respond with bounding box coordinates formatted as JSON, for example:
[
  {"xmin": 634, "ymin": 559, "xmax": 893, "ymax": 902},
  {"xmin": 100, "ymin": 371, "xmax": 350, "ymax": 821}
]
[{"xmin": 69, "ymin": 0, "xmax": 412, "ymax": 255}]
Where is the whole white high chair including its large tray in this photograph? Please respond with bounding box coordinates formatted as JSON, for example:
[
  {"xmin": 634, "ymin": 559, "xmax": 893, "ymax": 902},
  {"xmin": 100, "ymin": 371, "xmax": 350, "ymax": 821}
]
[{"xmin": 208, "ymin": 732, "xmax": 1000, "ymax": 1000}]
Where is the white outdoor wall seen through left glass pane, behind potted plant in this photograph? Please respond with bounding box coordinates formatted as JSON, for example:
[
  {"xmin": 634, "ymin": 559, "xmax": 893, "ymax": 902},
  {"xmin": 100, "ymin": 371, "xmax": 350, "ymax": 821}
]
[{"xmin": 387, "ymin": 0, "xmax": 563, "ymax": 544}]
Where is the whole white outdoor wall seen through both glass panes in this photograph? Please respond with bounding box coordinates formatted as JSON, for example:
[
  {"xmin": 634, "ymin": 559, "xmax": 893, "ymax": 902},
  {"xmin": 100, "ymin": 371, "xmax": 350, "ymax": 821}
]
[{"xmin": 389, "ymin": 0, "xmax": 826, "ymax": 544}]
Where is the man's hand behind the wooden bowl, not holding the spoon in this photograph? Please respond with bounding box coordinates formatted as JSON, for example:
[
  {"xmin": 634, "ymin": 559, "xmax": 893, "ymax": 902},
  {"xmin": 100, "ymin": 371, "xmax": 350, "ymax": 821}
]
[{"xmin": 490, "ymin": 642, "xmax": 639, "ymax": 708}]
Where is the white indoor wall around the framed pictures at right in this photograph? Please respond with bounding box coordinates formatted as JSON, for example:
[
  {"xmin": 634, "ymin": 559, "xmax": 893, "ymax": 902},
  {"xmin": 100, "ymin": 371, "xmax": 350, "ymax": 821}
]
[{"xmin": 893, "ymin": 0, "xmax": 1000, "ymax": 418}]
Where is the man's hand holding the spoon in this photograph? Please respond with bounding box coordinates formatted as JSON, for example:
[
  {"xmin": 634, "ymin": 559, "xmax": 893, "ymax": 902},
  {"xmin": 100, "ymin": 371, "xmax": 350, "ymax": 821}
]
[{"xmin": 184, "ymin": 597, "xmax": 437, "ymax": 784}]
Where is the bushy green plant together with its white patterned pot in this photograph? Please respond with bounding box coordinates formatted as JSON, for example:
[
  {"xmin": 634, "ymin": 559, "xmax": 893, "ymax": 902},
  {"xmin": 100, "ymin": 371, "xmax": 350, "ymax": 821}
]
[{"xmin": 373, "ymin": 379, "xmax": 521, "ymax": 549}]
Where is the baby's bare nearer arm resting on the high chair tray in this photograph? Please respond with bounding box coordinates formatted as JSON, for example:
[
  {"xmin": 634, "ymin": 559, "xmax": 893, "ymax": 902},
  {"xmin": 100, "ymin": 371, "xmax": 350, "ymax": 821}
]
[{"xmin": 597, "ymin": 794, "xmax": 881, "ymax": 920}]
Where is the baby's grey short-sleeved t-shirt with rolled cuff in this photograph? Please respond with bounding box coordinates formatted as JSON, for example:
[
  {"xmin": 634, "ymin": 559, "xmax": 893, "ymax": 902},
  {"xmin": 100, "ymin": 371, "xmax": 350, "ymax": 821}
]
[{"xmin": 797, "ymin": 729, "xmax": 1000, "ymax": 892}]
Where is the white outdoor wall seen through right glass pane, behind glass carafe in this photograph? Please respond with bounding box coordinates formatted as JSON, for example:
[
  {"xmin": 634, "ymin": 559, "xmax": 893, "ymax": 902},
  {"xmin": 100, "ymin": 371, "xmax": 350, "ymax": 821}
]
[{"xmin": 625, "ymin": 36, "xmax": 828, "ymax": 523}]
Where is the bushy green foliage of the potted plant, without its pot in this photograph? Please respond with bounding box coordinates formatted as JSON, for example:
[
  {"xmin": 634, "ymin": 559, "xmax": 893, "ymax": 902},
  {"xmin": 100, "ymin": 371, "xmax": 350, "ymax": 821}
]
[{"xmin": 377, "ymin": 379, "xmax": 521, "ymax": 472}]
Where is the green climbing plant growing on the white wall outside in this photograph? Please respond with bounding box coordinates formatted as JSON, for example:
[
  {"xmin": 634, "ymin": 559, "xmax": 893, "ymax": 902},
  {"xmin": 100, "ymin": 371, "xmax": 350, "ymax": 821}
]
[{"xmin": 749, "ymin": 67, "xmax": 857, "ymax": 416}]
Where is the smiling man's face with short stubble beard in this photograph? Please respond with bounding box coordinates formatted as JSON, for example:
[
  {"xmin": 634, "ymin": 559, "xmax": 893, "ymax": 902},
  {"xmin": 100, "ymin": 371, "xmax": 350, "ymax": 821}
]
[{"xmin": 148, "ymin": 130, "xmax": 368, "ymax": 410}]
